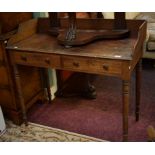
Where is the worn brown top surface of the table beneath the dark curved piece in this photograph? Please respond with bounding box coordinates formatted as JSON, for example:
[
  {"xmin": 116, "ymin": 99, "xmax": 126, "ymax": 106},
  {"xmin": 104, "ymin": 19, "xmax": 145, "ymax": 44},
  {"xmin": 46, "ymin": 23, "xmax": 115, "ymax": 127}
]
[{"xmin": 7, "ymin": 33, "xmax": 137, "ymax": 60}]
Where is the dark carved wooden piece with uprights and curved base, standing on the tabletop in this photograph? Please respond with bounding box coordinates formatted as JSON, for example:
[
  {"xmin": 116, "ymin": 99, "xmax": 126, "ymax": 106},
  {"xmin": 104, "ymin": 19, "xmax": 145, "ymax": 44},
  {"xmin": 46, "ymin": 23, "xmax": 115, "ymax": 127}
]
[{"xmin": 49, "ymin": 12, "xmax": 129, "ymax": 47}]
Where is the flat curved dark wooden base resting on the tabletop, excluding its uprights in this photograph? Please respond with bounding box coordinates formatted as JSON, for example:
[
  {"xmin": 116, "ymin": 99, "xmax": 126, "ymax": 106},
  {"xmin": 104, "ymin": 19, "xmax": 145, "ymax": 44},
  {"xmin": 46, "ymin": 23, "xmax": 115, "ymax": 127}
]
[{"xmin": 57, "ymin": 29, "xmax": 129, "ymax": 46}]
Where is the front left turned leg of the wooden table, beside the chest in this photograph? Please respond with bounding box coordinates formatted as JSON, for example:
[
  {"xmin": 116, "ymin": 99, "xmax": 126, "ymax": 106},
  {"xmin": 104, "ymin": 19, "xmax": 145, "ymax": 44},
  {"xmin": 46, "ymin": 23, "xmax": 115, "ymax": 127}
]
[{"xmin": 13, "ymin": 64, "xmax": 28, "ymax": 126}]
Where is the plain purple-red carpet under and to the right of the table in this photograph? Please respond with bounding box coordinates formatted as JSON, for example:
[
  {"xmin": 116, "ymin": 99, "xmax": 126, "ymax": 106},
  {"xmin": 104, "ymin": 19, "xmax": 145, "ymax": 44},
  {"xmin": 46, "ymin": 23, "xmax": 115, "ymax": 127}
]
[{"xmin": 28, "ymin": 60, "xmax": 155, "ymax": 141}]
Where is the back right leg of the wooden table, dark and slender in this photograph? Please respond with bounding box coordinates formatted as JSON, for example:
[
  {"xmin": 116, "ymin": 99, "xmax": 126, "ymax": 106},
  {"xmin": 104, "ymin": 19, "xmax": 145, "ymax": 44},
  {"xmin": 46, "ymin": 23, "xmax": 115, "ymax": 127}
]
[{"xmin": 135, "ymin": 60, "xmax": 141, "ymax": 121}]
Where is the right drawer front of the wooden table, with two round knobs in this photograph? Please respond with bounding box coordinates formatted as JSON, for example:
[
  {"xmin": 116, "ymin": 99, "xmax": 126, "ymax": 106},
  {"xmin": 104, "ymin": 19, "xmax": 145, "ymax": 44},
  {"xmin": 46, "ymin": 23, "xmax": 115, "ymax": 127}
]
[{"xmin": 62, "ymin": 56, "xmax": 122, "ymax": 75}]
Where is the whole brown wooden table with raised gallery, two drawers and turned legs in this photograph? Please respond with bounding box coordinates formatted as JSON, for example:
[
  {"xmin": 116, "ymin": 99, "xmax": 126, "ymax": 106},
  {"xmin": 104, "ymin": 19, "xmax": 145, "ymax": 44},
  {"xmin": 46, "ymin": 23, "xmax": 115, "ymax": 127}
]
[{"xmin": 7, "ymin": 19, "xmax": 146, "ymax": 141}]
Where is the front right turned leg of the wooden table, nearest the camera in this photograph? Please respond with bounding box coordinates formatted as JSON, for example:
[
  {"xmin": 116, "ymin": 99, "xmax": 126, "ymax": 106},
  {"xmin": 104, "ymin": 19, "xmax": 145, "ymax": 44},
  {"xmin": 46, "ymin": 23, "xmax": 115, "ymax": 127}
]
[{"xmin": 122, "ymin": 80, "xmax": 130, "ymax": 141}]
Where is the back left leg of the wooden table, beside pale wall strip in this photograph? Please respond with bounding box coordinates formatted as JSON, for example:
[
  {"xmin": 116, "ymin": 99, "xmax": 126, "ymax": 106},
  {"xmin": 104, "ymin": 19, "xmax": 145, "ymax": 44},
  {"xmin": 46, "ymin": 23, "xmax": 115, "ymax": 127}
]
[{"xmin": 43, "ymin": 68, "xmax": 52, "ymax": 103}]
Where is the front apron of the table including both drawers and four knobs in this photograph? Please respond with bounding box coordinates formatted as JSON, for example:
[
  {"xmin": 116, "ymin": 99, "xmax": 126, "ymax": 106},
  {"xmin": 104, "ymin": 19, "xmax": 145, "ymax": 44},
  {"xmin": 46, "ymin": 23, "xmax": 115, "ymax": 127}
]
[{"xmin": 12, "ymin": 51, "xmax": 128, "ymax": 77}]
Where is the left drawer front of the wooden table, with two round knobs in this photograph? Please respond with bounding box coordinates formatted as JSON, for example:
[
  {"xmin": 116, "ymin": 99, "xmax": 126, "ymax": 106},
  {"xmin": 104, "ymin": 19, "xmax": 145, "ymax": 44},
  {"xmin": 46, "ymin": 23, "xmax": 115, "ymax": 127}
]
[{"xmin": 14, "ymin": 52, "xmax": 60, "ymax": 68}]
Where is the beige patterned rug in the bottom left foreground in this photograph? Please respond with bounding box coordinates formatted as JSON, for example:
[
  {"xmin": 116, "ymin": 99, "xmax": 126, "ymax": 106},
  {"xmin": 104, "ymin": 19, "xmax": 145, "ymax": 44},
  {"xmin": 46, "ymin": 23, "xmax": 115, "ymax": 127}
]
[{"xmin": 0, "ymin": 121, "xmax": 103, "ymax": 142}]
